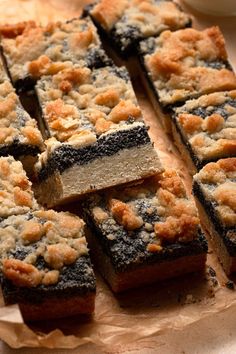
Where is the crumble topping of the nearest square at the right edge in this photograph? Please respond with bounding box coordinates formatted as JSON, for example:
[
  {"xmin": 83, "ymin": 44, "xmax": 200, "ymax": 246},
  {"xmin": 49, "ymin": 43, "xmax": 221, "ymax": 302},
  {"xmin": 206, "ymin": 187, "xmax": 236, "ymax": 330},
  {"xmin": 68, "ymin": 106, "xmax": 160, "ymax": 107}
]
[{"xmin": 194, "ymin": 158, "xmax": 236, "ymax": 227}]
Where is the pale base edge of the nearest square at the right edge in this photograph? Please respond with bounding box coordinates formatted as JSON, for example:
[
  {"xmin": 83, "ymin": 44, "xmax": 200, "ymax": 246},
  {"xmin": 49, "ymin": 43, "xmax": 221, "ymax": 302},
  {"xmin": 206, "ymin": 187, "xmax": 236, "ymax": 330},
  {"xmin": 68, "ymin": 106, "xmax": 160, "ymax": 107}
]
[{"xmin": 195, "ymin": 196, "xmax": 236, "ymax": 275}]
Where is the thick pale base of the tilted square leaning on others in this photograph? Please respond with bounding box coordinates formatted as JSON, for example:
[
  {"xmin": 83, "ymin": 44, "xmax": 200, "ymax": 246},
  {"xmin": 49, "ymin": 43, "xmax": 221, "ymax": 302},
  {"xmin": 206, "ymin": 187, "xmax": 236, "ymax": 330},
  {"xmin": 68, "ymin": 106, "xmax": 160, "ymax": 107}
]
[{"xmin": 37, "ymin": 144, "xmax": 163, "ymax": 207}]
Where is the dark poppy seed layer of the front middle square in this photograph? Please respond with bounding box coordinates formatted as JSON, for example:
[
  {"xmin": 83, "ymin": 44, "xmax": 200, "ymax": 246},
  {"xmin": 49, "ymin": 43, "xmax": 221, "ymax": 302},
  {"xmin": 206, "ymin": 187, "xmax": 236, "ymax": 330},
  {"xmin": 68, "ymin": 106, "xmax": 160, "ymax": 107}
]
[{"xmin": 84, "ymin": 199, "xmax": 208, "ymax": 273}]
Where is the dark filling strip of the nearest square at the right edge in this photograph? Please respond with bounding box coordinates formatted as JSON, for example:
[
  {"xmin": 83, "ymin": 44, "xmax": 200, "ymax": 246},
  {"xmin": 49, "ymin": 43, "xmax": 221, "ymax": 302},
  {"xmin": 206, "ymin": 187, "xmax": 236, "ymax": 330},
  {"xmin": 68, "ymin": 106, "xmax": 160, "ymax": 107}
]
[{"xmin": 193, "ymin": 181, "xmax": 236, "ymax": 257}]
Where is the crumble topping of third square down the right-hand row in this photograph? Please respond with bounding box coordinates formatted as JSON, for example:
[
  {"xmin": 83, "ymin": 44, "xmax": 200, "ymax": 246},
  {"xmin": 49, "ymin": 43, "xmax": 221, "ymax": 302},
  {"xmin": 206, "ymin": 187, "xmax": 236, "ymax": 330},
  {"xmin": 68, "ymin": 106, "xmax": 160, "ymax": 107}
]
[{"xmin": 174, "ymin": 91, "xmax": 236, "ymax": 160}]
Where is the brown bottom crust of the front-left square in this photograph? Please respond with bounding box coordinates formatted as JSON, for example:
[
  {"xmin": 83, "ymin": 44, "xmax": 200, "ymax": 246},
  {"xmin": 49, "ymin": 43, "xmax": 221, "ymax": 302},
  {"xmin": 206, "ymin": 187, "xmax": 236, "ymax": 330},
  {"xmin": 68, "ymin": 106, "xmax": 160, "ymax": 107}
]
[{"xmin": 19, "ymin": 292, "xmax": 95, "ymax": 321}]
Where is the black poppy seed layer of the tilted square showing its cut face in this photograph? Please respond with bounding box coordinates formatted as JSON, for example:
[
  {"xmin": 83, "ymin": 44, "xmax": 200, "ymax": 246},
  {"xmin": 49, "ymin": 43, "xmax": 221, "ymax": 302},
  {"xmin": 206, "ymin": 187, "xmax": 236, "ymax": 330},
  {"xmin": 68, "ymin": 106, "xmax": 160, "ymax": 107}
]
[{"xmin": 38, "ymin": 125, "xmax": 150, "ymax": 181}]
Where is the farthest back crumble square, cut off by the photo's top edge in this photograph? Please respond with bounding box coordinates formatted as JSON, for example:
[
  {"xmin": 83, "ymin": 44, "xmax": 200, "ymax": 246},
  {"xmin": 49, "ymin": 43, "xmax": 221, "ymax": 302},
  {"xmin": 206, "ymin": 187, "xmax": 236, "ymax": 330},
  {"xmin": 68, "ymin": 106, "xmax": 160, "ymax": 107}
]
[{"xmin": 85, "ymin": 0, "xmax": 191, "ymax": 58}]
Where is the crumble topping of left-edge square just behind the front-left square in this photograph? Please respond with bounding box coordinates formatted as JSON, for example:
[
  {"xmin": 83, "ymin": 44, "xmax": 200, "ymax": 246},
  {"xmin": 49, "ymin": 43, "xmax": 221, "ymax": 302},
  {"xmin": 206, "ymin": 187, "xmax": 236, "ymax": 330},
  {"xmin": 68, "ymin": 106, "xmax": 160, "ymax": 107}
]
[{"xmin": 0, "ymin": 156, "xmax": 38, "ymax": 218}]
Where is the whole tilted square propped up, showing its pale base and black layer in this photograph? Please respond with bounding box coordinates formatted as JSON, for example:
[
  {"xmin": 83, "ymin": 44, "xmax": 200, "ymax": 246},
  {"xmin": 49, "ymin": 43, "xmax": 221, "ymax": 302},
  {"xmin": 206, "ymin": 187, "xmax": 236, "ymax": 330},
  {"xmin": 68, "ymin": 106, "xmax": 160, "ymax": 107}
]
[{"xmin": 36, "ymin": 66, "xmax": 162, "ymax": 206}]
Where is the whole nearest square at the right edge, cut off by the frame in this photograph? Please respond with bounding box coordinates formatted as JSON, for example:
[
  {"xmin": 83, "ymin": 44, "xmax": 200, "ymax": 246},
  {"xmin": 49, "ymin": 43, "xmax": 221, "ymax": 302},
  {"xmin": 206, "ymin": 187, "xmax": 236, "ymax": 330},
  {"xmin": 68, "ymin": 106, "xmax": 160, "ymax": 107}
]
[{"xmin": 193, "ymin": 158, "xmax": 236, "ymax": 275}]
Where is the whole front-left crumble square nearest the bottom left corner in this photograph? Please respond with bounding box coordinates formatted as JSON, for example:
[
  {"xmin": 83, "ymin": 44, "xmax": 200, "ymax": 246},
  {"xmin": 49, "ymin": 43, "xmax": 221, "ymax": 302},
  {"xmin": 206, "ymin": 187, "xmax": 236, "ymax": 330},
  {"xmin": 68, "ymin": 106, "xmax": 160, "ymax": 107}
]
[{"xmin": 0, "ymin": 210, "xmax": 96, "ymax": 321}]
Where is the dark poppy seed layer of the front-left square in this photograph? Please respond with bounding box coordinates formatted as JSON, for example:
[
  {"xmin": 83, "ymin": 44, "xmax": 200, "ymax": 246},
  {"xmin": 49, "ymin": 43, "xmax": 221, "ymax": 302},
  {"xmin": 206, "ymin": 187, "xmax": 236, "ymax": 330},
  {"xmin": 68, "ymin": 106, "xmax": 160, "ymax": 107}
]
[{"xmin": 1, "ymin": 251, "xmax": 96, "ymax": 304}]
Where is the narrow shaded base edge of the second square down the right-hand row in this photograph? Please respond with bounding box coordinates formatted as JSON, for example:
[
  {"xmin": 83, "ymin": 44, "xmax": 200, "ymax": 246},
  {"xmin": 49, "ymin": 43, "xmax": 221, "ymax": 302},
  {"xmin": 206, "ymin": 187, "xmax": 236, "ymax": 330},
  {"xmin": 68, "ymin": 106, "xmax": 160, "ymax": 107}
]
[{"xmin": 137, "ymin": 60, "xmax": 172, "ymax": 134}]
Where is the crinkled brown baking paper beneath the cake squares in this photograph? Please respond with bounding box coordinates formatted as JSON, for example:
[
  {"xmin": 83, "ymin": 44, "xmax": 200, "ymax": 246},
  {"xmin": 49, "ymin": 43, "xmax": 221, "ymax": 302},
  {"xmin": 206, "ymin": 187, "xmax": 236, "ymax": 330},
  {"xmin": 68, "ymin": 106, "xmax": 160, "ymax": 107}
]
[{"xmin": 0, "ymin": 0, "xmax": 236, "ymax": 350}]
